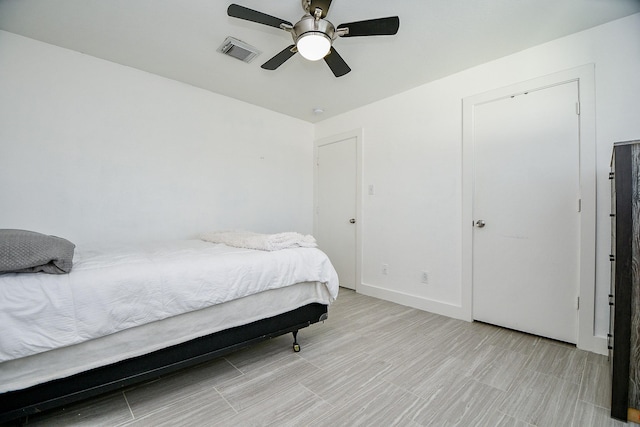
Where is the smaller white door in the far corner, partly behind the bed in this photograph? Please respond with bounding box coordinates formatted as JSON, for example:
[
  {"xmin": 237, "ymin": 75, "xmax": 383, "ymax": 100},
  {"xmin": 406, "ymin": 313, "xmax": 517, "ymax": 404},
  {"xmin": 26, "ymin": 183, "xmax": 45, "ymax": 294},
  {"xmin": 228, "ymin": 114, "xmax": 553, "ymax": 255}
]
[{"xmin": 315, "ymin": 137, "xmax": 357, "ymax": 289}]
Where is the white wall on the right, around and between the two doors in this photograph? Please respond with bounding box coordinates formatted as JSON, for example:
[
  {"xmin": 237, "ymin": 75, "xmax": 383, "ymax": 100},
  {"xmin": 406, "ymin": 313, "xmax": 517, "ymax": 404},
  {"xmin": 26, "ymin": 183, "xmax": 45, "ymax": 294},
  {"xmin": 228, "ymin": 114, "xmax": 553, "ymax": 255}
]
[{"xmin": 315, "ymin": 14, "xmax": 640, "ymax": 348}]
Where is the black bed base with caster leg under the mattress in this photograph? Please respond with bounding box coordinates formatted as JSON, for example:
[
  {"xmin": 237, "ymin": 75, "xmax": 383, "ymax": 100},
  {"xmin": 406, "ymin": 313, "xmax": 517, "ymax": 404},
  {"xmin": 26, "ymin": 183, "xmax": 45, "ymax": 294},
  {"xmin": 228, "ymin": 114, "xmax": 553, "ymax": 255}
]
[{"xmin": 0, "ymin": 303, "xmax": 327, "ymax": 422}]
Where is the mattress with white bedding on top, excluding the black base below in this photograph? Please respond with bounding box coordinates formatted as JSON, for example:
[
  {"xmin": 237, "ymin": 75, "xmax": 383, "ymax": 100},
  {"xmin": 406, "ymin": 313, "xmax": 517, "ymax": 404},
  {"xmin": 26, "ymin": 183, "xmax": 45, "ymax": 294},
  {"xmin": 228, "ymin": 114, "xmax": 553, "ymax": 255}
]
[{"xmin": 0, "ymin": 240, "xmax": 338, "ymax": 392}]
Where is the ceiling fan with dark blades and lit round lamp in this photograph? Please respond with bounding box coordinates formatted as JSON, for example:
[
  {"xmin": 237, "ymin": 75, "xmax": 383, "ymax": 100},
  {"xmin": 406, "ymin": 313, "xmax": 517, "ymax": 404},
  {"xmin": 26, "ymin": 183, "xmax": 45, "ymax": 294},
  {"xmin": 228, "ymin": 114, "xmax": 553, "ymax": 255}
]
[{"xmin": 227, "ymin": 0, "xmax": 400, "ymax": 77}]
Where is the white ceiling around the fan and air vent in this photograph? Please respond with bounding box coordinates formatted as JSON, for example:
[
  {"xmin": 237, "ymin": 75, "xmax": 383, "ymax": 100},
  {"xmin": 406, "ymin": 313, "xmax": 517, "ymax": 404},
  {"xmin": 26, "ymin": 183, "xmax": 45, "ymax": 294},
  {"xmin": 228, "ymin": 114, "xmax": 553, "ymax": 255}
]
[{"xmin": 0, "ymin": 0, "xmax": 640, "ymax": 122}]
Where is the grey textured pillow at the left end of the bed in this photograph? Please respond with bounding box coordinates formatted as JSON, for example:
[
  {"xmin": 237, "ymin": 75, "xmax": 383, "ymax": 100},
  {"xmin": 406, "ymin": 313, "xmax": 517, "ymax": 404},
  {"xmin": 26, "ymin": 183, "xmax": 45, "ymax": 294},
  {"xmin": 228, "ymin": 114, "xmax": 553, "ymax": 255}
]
[{"xmin": 0, "ymin": 229, "xmax": 76, "ymax": 274}]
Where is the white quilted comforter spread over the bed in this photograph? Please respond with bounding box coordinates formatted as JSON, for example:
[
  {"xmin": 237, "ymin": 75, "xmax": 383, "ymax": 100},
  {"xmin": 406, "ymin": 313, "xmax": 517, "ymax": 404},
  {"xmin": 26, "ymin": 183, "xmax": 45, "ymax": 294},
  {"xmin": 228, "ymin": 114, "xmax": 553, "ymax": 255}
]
[{"xmin": 0, "ymin": 240, "xmax": 338, "ymax": 362}]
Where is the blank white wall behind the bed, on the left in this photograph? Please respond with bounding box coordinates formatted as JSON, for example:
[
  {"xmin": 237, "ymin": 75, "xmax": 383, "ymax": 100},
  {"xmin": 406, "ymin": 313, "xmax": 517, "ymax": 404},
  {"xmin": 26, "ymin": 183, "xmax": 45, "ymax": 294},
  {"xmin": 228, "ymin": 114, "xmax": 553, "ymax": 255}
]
[{"xmin": 0, "ymin": 31, "xmax": 313, "ymax": 243}]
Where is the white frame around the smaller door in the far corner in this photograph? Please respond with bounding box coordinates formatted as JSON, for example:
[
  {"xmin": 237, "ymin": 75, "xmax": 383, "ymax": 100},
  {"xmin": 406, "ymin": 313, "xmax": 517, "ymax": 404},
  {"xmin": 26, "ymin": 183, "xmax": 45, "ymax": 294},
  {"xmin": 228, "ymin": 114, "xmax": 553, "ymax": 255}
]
[{"xmin": 313, "ymin": 128, "xmax": 363, "ymax": 292}]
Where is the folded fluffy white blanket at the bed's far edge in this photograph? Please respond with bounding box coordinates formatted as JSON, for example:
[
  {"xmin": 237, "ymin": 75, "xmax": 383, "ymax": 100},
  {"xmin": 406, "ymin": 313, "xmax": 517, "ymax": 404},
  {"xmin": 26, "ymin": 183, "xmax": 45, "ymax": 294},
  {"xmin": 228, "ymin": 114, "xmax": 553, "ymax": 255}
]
[{"xmin": 200, "ymin": 230, "xmax": 317, "ymax": 251}]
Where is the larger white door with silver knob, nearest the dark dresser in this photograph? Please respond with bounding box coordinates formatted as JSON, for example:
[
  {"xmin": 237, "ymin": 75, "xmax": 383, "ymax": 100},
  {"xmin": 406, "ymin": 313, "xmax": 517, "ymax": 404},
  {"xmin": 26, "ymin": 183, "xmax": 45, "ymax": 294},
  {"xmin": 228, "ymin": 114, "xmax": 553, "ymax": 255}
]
[{"xmin": 473, "ymin": 82, "xmax": 580, "ymax": 343}]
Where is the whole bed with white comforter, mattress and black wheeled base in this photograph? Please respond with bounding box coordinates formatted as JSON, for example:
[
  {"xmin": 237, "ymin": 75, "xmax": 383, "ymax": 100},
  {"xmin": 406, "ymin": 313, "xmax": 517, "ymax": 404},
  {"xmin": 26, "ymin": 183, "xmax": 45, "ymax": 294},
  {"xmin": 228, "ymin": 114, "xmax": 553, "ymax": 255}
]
[{"xmin": 0, "ymin": 234, "xmax": 338, "ymax": 422}]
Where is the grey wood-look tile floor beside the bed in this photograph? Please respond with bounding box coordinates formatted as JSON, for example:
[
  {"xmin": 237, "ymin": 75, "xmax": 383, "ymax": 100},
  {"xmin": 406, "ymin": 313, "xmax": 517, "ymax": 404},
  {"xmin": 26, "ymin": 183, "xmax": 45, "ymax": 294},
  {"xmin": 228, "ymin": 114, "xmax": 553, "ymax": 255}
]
[{"xmin": 16, "ymin": 289, "xmax": 626, "ymax": 427}]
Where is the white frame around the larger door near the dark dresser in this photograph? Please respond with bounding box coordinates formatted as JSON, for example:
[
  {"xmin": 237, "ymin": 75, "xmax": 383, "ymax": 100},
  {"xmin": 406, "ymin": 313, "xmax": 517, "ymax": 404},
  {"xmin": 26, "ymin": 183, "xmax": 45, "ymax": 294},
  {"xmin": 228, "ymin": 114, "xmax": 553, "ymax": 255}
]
[{"xmin": 462, "ymin": 64, "xmax": 607, "ymax": 354}]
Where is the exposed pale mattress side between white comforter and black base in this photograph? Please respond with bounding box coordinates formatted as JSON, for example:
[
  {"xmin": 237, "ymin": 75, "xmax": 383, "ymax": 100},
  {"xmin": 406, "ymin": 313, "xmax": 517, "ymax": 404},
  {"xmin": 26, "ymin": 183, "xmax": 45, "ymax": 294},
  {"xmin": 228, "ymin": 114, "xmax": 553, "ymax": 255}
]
[{"xmin": 0, "ymin": 282, "xmax": 335, "ymax": 393}]
